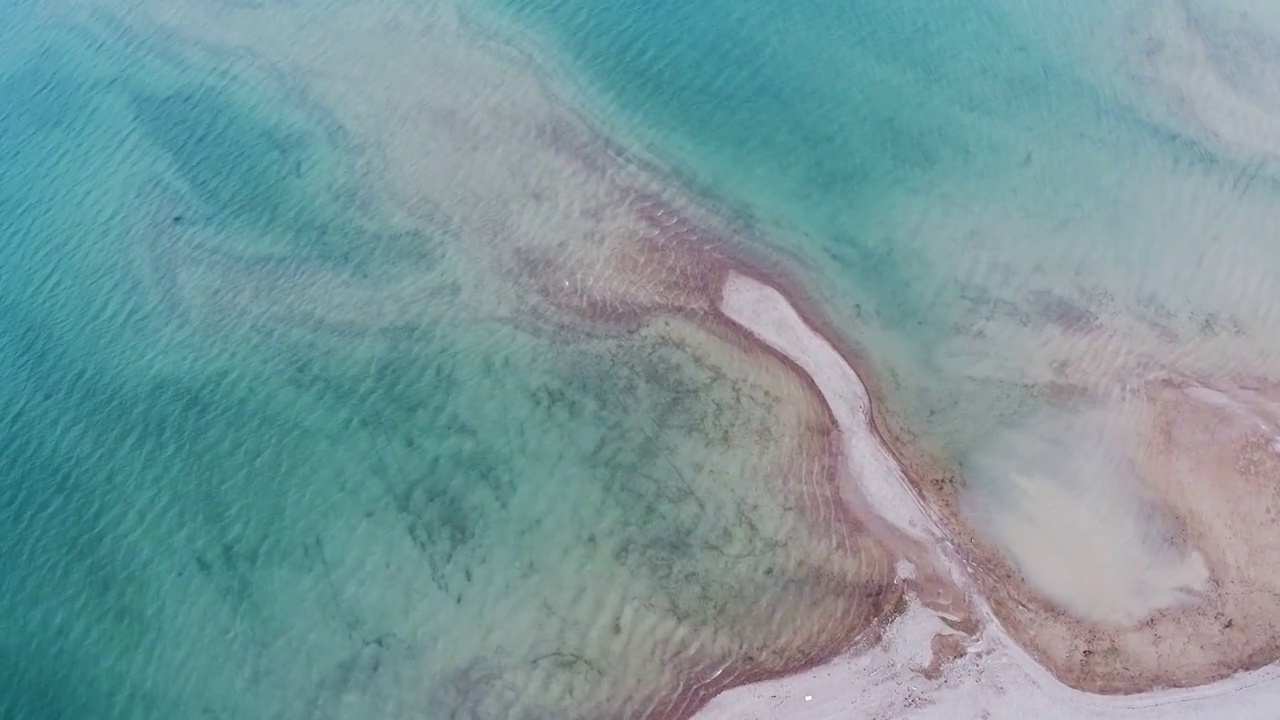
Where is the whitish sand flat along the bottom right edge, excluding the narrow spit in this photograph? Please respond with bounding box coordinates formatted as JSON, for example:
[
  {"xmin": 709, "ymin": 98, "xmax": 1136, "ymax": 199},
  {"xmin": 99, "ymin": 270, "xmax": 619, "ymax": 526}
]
[{"xmin": 695, "ymin": 607, "xmax": 1280, "ymax": 720}]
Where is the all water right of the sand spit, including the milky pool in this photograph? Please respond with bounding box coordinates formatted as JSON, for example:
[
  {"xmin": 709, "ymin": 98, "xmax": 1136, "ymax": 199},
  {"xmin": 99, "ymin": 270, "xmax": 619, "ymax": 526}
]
[{"xmin": 486, "ymin": 0, "xmax": 1280, "ymax": 619}]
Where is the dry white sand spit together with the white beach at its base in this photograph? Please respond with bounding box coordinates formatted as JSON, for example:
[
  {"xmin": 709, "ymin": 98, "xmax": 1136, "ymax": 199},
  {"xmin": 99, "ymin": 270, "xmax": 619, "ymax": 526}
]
[{"xmin": 716, "ymin": 274, "xmax": 1280, "ymax": 720}]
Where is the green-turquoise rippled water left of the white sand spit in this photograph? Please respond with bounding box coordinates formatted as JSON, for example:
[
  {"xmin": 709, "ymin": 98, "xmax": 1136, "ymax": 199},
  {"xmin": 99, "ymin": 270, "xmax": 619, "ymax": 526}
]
[{"xmin": 0, "ymin": 2, "xmax": 880, "ymax": 719}]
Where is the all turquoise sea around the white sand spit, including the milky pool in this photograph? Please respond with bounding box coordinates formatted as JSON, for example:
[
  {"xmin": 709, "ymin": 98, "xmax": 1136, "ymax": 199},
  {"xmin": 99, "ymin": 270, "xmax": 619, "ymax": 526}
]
[{"xmin": 0, "ymin": 0, "xmax": 1280, "ymax": 719}]
